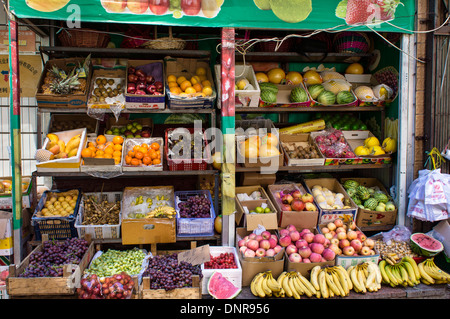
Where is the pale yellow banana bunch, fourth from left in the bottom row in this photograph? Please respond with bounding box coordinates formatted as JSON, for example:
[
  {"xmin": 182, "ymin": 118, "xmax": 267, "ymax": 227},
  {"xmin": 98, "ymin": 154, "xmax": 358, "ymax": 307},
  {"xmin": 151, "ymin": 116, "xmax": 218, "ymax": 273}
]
[{"xmin": 347, "ymin": 261, "xmax": 383, "ymax": 294}]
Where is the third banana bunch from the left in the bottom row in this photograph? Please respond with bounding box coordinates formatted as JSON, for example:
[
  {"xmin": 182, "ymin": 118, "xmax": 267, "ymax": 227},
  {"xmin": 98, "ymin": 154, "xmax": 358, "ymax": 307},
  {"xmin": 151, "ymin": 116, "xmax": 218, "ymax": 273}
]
[{"xmin": 309, "ymin": 265, "xmax": 353, "ymax": 299}]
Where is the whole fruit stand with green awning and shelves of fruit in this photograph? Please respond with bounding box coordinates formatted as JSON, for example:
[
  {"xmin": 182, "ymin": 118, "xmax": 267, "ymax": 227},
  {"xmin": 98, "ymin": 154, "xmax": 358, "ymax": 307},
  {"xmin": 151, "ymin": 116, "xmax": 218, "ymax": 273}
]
[{"xmin": 6, "ymin": 0, "xmax": 449, "ymax": 299}]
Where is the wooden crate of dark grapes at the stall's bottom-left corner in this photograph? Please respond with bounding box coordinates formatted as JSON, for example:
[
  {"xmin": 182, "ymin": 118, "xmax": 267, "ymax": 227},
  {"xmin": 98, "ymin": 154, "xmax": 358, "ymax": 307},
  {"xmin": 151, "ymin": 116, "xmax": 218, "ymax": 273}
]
[{"xmin": 6, "ymin": 235, "xmax": 94, "ymax": 298}]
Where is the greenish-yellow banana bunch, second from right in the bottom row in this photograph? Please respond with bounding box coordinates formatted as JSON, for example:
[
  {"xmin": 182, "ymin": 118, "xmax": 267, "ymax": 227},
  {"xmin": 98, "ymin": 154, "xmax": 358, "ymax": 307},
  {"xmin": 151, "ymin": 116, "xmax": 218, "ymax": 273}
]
[{"xmin": 378, "ymin": 256, "xmax": 422, "ymax": 287}]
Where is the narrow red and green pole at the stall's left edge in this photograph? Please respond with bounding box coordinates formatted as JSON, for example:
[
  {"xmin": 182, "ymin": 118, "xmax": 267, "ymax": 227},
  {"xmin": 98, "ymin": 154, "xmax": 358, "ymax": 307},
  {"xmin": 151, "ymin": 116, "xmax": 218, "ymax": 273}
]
[{"xmin": 9, "ymin": 13, "xmax": 22, "ymax": 264}]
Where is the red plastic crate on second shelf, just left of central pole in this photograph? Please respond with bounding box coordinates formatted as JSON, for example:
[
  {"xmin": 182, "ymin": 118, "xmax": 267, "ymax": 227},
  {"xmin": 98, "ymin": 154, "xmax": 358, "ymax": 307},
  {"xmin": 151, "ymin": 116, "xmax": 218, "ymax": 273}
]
[{"xmin": 164, "ymin": 128, "xmax": 210, "ymax": 171}]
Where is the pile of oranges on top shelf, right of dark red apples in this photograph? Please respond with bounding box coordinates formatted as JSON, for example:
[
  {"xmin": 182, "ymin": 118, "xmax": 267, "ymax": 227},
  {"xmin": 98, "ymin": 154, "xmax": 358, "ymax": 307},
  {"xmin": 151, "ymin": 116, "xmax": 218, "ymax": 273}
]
[{"xmin": 167, "ymin": 67, "xmax": 213, "ymax": 97}]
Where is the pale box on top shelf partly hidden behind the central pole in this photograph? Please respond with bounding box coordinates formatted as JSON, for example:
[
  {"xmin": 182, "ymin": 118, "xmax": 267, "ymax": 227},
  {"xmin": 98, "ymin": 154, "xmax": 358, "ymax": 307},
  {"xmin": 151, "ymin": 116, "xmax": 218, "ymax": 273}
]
[{"xmin": 214, "ymin": 64, "xmax": 261, "ymax": 109}]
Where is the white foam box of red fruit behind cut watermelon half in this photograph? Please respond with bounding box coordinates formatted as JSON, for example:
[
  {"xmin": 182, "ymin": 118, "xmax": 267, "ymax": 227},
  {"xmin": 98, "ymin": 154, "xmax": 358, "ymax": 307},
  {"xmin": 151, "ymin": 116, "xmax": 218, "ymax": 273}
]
[{"xmin": 201, "ymin": 246, "xmax": 242, "ymax": 294}]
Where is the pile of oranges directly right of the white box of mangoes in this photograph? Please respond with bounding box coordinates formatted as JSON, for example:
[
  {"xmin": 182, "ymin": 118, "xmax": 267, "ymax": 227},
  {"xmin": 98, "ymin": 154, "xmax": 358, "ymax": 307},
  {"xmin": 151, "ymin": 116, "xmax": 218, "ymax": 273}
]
[{"xmin": 81, "ymin": 135, "xmax": 123, "ymax": 165}]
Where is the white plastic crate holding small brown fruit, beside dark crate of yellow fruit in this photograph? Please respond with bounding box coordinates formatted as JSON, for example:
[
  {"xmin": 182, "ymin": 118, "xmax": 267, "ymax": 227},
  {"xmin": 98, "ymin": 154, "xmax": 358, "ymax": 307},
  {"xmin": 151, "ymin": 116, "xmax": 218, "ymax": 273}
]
[{"xmin": 75, "ymin": 192, "xmax": 123, "ymax": 239}]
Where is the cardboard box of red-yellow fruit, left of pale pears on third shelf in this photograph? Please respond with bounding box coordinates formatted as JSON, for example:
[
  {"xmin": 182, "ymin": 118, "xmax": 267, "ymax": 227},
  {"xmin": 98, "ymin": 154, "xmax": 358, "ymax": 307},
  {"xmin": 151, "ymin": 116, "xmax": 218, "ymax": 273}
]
[{"xmin": 267, "ymin": 183, "xmax": 319, "ymax": 229}]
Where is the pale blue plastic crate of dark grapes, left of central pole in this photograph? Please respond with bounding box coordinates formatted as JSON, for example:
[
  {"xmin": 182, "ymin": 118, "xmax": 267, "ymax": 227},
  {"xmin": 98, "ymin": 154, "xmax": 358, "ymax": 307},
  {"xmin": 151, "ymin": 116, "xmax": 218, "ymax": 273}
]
[{"xmin": 175, "ymin": 190, "xmax": 216, "ymax": 237}]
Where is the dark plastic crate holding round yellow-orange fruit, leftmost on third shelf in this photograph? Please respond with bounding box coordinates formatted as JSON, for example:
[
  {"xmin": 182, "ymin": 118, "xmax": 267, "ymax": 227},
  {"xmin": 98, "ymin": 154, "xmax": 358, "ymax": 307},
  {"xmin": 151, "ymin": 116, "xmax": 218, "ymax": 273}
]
[{"xmin": 31, "ymin": 189, "xmax": 81, "ymax": 241}]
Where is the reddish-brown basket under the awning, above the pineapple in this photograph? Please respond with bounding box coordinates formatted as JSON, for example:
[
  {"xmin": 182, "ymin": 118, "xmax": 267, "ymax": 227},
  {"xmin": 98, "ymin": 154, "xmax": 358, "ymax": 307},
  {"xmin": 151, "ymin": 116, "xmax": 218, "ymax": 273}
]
[{"xmin": 58, "ymin": 29, "xmax": 110, "ymax": 48}]
